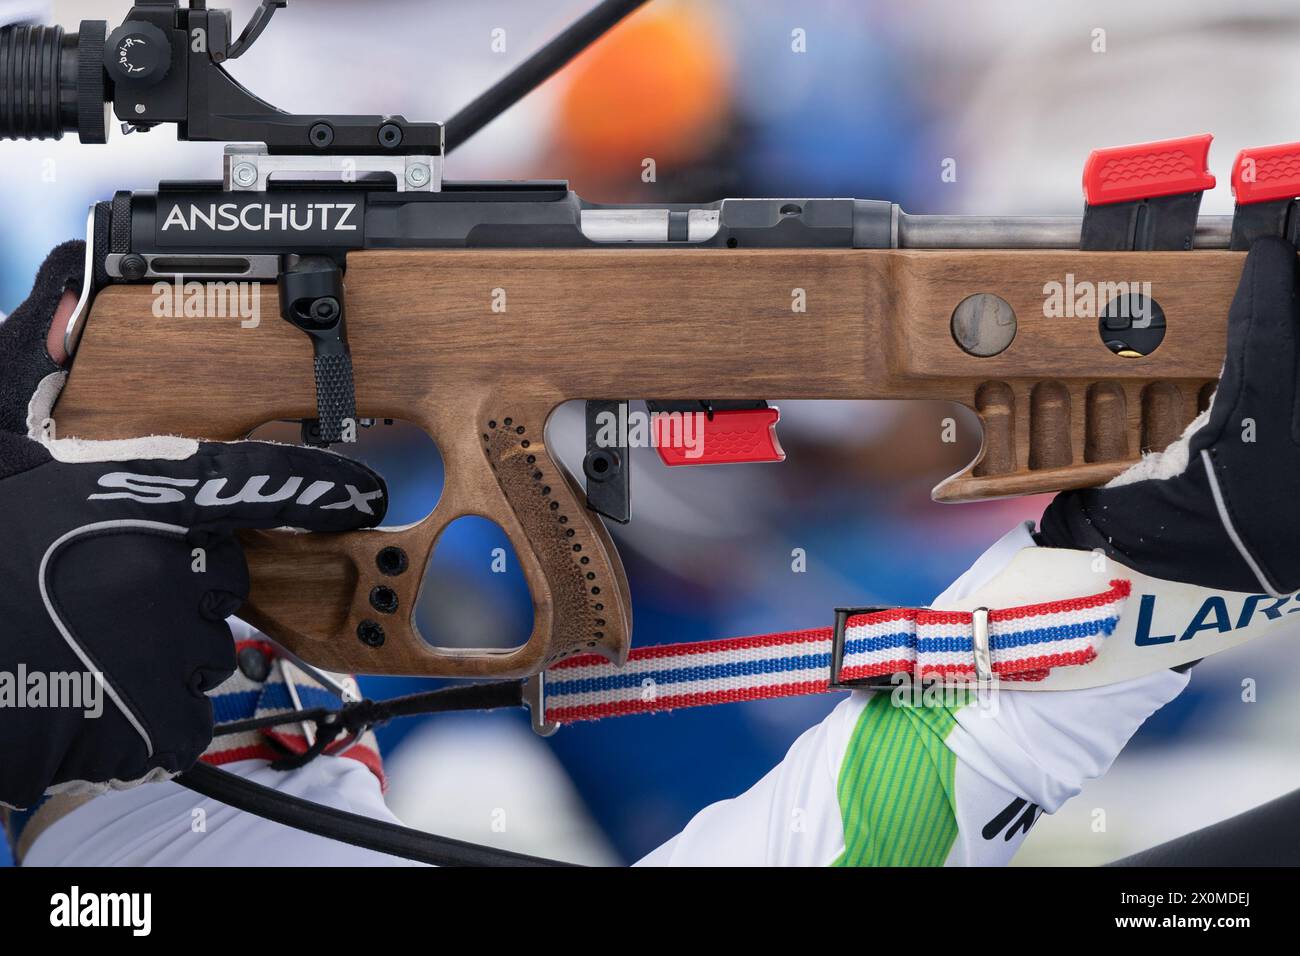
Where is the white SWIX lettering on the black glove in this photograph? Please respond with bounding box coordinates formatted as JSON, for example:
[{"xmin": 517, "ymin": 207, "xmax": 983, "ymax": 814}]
[{"xmin": 88, "ymin": 471, "xmax": 384, "ymax": 515}]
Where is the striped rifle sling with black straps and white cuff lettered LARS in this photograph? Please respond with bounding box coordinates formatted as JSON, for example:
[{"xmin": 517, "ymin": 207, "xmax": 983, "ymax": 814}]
[{"xmin": 165, "ymin": 548, "xmax": 1296, "ymax": 866}]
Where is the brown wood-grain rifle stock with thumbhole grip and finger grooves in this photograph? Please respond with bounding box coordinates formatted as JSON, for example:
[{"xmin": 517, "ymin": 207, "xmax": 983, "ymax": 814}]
[{"xmin": 48, "ymin": 248, "xmax": 1227, "ymax": 676}]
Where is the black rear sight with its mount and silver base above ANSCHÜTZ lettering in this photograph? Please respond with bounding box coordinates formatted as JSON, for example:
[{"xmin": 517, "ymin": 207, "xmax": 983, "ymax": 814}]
[{"xmin": 0, "ymin": 0, "xmax": 443, "ymax": 185}]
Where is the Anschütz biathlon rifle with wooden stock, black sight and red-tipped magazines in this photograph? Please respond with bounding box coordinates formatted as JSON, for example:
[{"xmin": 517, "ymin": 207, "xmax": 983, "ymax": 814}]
[{"xmin": 0, "ymin": 0, "xmax": 1300, "ymax": 678}]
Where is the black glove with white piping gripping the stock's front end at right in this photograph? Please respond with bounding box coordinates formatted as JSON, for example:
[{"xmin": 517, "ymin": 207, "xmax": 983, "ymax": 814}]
[{"xmin": 1039, "ymin": 238, "xmax": 1300, "ymax": 596}]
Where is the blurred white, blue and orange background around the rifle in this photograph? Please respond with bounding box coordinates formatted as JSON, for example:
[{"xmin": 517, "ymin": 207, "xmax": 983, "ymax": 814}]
[{"xmin": 0, "ymin": 0, "xmax": 1300, "ymax": 864}]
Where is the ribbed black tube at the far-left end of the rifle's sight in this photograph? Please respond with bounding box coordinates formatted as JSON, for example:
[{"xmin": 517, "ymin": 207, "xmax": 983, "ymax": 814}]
[{"xmin": 0, "ymin": 20, "xmax": 112, "ymax": 143}]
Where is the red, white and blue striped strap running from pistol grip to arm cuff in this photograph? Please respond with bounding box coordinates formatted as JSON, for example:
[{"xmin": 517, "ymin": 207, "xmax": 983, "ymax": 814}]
[{"xmin": 542, "ymin": 580, "xmax": 1131, "ymax": 723}]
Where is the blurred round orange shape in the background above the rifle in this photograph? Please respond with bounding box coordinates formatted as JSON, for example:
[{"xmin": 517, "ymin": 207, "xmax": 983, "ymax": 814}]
[{"xmin": 555, "ymin": 3, "xmax": 731, "ymax": 172}]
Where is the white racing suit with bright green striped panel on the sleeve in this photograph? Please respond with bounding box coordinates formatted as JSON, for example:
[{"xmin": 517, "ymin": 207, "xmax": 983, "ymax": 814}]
[{"xmin": 15, "ymin": 527, "xmax": 1188, "ymax": 866}]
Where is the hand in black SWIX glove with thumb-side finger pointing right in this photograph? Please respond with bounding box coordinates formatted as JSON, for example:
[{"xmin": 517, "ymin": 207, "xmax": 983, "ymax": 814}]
[{"xmin": 0, "ymin": 243, "xmax": 386, "ymax": 806}]
